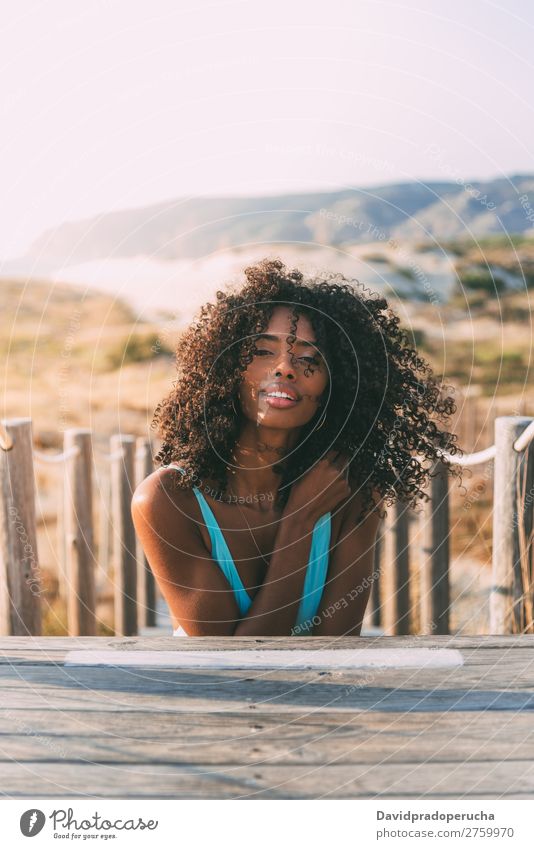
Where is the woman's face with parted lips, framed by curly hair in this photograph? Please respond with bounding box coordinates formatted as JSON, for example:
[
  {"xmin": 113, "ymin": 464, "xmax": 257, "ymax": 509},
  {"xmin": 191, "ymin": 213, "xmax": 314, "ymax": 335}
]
[{"xmin": 239, "ymin": 306, "xmax": 329, "ymax": 429}]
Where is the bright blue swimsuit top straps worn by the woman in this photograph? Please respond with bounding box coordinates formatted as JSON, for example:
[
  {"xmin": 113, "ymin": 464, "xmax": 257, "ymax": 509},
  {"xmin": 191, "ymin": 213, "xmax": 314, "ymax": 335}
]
[{"xmin": 166, "ymin": 463, "xmax": 332, "ymax": 635}]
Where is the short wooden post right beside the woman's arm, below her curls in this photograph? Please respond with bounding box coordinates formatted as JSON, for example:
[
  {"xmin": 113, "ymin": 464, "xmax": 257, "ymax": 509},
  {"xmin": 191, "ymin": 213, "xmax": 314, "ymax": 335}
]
[{"xmin": 381, "ymin": 501, "xmax": 411, "ymax": 636}]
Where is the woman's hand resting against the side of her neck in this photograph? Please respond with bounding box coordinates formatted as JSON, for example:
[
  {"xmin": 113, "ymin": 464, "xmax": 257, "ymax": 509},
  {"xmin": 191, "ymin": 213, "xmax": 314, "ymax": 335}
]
[{"xmin": 283, "ymin": 450, "xmax": 351, "ymax": 525}]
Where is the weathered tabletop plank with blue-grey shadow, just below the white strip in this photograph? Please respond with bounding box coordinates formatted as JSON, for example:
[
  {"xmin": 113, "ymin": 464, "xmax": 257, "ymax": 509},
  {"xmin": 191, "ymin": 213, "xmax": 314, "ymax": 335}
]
[{"xmin": 2, "ymin": 675, "xmax": 534, "ymax": 716}]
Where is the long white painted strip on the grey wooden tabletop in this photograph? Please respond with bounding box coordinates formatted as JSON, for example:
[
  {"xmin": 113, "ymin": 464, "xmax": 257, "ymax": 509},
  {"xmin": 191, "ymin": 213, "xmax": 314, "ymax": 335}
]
[{"xmin": 64, "ymin": 648, "xmax": 464, "ymax": 669}]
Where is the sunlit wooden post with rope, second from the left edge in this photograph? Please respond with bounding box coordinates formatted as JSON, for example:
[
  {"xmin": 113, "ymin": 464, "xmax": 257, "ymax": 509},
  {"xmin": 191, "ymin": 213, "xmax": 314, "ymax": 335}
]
[{"xmin": 64, "ymin": 428, "xmax": 96, "ymax": 637}]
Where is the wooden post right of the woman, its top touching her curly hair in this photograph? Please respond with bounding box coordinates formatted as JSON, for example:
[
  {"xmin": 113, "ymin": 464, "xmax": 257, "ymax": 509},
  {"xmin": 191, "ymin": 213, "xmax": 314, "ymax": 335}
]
[{"xmin": 420, "ymin": 461, "xmax": 450, "ymax": 634}]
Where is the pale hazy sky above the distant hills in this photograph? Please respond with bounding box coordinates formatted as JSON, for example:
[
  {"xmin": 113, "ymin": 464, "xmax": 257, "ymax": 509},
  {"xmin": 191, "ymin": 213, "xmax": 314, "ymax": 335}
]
[{"xmin": 0, "ymin": 0, "xmax": 534, "ymax": 258}]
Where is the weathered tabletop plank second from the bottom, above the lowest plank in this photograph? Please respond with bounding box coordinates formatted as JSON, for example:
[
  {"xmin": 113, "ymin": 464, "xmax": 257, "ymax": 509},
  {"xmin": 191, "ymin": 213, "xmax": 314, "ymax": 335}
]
[{"xmin": 0, "ymin": 713, "xmax": 534, "ymax": 767}]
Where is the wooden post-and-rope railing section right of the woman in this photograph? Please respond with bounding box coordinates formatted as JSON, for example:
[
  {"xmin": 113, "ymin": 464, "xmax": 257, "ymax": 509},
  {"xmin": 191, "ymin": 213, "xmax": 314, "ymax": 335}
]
[{"xmin": 371, "ymin": 416, "xmax": 534, "ymax": 635}]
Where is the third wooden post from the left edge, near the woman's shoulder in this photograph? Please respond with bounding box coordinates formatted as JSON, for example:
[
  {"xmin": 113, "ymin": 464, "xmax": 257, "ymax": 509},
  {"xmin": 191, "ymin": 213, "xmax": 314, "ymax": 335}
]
[{"xmin": 110, "ymin": 433, "xmax": 137, "ymax": 637}]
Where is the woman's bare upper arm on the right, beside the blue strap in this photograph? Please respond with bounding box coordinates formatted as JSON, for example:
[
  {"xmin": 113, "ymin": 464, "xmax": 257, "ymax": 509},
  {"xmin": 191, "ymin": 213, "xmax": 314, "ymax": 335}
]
[{"xmin": 313, "ymin": 486, "xmax": 382, "ymax": 637}]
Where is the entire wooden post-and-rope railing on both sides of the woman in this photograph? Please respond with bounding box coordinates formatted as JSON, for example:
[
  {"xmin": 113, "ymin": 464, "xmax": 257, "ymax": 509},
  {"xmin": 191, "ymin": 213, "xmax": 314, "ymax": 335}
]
[{"xmin": 0, "ymin": 416, "xmax": 534, "ymax": 636}]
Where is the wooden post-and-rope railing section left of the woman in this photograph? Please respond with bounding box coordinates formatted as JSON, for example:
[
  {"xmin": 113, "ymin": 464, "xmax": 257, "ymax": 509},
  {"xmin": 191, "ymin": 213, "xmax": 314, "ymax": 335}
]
[{"xmin": 0, "ymin": 419, "xmax": 156, "ymax": 636}]
